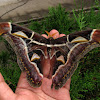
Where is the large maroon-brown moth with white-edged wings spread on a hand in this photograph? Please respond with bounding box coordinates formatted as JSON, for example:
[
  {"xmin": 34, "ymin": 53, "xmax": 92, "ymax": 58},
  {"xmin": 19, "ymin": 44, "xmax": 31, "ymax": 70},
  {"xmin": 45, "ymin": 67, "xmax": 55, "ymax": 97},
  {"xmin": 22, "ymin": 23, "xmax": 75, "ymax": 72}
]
[{"xmin": 0, "ymin": 22, "xmax": 100, "ymax": 89}]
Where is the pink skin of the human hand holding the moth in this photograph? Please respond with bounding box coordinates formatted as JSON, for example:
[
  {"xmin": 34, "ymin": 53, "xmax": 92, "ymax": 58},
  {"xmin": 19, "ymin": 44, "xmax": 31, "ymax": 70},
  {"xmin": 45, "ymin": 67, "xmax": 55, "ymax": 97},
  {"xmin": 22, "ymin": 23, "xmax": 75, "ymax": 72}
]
[{"xmin": 0, "ymin": 31, "xmax": 71, "ymax": 100}]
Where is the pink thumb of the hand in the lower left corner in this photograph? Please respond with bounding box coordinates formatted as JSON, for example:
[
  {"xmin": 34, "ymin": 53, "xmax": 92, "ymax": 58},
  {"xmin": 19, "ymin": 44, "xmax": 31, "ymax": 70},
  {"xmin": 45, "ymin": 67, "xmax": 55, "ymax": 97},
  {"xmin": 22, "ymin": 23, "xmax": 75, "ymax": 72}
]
[{"xmin": 0, "ymin": 73, "xmax": 15, "ymax": 100}]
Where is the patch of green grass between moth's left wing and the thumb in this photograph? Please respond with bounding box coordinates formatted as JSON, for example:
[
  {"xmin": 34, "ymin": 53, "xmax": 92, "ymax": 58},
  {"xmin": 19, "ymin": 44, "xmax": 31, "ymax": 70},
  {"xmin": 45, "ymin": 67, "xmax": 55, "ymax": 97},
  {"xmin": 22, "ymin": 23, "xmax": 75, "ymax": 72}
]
[{"xmin": 0, "ymin": 43, "xmax": 21, "ymax": 91}]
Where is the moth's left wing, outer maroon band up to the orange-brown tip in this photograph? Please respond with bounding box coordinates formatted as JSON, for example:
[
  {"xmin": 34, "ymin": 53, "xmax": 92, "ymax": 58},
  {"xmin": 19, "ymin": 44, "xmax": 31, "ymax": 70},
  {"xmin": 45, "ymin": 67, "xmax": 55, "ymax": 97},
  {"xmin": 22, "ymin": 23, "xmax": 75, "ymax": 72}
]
[{"xmin": 0, "ymin": 22, "xmax": 46, "ymax": 87}]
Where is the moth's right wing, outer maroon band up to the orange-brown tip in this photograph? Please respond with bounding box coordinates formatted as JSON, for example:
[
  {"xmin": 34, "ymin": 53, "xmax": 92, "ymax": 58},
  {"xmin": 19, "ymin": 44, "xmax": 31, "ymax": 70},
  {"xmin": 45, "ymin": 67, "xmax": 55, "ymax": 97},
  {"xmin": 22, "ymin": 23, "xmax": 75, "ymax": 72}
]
[{"xmin": 52, "ymin": 30, "xmax": 100, "ymax": 89}]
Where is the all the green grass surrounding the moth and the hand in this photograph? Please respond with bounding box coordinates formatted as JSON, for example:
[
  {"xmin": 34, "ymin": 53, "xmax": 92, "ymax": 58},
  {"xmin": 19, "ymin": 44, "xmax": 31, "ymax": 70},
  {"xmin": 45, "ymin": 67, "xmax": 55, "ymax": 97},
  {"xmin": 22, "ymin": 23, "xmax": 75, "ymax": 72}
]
[{"xmin": 0, "ymin": 0, "xmax": 100, "ymax": 100}]
